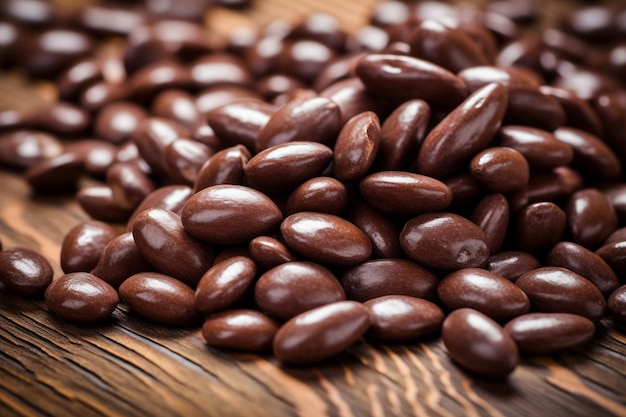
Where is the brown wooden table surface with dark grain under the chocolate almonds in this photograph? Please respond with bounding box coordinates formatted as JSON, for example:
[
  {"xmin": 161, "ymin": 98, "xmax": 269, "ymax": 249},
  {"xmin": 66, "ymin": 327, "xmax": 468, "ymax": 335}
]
[{"xmin": 0, "ymin": 0, "xmax": 626, "ymax": 417}]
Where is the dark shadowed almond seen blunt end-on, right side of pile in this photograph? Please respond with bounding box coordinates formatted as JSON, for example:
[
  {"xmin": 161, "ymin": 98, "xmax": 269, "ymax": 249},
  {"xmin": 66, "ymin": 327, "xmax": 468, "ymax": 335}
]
[{"xmin": 517, "ymin": 202, "xmax": 567, "ymax": 254}]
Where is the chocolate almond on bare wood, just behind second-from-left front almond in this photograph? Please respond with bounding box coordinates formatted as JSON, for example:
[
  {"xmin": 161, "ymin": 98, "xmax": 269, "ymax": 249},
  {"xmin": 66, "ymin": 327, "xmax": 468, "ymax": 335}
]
[{"xmin": 61, "ymin": 220, "xmax": 117, "ymax": 274}]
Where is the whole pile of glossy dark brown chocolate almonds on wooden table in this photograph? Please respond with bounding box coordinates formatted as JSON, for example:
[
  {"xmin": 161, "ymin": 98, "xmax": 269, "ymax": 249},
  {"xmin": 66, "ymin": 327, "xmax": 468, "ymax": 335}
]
[{"xmin": 0, "ymin": 0, "xmax": 626, "ymax": 377}]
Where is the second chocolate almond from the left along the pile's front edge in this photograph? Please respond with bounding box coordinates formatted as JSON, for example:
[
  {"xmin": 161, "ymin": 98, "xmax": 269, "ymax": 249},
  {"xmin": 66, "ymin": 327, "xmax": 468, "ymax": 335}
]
[{"xmin": 45, "ymin": 272, "xmax": 119, "ymax": 324}]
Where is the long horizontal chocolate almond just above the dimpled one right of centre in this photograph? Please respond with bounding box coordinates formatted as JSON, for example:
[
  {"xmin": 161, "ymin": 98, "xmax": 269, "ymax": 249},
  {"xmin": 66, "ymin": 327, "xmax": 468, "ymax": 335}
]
[{"xmin": 359, "ymin": 171, "xmax": 452, "ymax": 217}]
